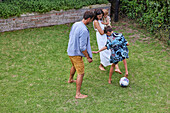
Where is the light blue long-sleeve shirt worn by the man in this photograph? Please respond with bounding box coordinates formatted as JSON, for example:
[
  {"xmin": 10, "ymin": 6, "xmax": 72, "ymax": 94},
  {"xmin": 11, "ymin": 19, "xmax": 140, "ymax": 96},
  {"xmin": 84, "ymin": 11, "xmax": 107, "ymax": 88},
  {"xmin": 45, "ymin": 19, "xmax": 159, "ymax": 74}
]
[{"xmin": 67, "ymin": 21, "xmax": 92, "ymax": 58}]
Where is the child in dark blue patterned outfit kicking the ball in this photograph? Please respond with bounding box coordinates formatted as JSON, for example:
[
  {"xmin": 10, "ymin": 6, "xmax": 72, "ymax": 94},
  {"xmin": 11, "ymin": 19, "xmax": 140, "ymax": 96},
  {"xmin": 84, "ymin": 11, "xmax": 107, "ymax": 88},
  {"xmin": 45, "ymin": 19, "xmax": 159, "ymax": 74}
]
[{"xmin": 92, "ymin": 26, "xmax": 129, "ymax": 84}]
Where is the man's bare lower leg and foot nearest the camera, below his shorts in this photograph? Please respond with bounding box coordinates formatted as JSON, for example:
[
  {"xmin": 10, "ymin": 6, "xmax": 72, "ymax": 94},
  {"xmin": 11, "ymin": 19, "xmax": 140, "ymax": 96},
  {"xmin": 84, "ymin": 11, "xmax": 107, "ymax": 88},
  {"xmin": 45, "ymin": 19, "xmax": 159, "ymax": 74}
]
[{"xmin": 75, "ymin": 74, "xmax": 87, "ymax": 99}]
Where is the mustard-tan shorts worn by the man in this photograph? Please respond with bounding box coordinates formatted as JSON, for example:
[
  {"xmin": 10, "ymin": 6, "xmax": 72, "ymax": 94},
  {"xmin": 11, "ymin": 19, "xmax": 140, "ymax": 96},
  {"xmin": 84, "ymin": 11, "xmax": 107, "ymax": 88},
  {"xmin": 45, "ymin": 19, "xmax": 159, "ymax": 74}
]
[{"xmin": 69, "ymin": 56, "xmax": 84, "ymax": 74}]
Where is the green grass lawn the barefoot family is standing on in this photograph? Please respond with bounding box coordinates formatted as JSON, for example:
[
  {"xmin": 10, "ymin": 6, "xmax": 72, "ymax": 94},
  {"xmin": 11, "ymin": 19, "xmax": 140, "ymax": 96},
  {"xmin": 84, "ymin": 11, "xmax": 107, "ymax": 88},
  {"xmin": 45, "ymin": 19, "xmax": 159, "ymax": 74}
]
[{"xmin": 0, "ymin": 20, "xmax": 170, "ymax": 113}]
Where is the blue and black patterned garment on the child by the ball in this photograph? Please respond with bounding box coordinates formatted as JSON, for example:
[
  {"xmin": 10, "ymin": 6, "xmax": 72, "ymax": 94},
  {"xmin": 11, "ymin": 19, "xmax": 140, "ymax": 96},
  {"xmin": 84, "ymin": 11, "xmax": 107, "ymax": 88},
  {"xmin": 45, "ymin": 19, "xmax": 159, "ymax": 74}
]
[{"xmin": 106, "ymin": 33, "xmax": 129, "ymax": 64}]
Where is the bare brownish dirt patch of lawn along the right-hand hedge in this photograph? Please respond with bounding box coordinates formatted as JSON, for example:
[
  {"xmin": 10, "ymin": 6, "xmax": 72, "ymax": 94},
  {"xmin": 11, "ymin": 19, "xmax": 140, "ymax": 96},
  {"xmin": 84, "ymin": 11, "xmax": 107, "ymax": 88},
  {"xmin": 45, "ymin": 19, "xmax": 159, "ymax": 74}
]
[{"xmin": 112, "ymin": 18, "xmax": 169, "ymax": 52}]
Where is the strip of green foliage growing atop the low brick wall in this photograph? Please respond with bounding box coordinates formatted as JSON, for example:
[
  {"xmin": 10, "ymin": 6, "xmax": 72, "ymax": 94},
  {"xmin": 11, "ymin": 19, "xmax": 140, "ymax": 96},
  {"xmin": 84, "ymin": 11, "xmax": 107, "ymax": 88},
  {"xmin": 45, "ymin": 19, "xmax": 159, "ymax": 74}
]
[{"xmin": 0, "ymin": 0, "xmax": 108, "ymax": 18}]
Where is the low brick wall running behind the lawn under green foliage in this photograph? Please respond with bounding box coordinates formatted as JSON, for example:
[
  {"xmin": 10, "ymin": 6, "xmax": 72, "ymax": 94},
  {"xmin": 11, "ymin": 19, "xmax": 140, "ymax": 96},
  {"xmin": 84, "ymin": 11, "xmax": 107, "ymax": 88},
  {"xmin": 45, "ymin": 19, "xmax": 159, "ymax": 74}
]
[{"xmin": 0, "ymin": 3, "xmax": 111, "ymax": 32}]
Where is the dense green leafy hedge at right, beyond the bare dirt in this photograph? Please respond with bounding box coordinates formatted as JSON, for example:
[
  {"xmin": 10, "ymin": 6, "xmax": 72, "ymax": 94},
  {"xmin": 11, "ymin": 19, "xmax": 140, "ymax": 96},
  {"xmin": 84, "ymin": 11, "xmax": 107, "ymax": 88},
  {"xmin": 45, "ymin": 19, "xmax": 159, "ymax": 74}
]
[{"xmin": 120, "ymin": 0, "xmax": 170, "ymax": 42}]
